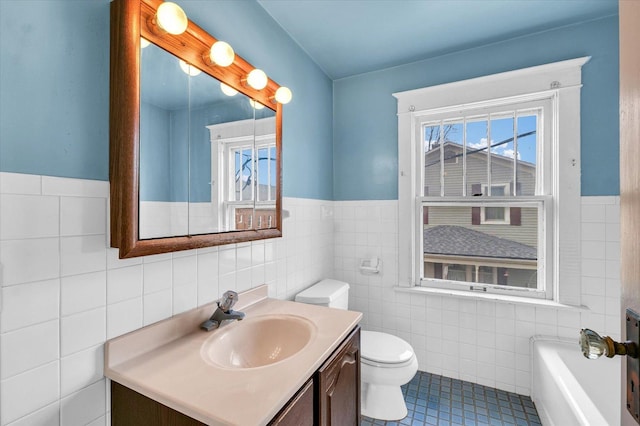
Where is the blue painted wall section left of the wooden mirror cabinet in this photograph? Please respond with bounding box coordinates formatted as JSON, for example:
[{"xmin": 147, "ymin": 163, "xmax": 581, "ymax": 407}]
[{"xmin": 0, "ymin": 0, "xmax": 109, "ymax": 180}]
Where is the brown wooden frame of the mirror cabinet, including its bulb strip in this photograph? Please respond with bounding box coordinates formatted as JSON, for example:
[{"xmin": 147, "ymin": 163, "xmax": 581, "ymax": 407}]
[{"xmin": 109, "ymin": 0, "xmax": 282, "ymax": 258}]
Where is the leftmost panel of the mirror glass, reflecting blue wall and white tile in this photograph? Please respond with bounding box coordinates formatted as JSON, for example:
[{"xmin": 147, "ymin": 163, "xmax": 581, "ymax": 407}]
[{"xmin": 139, "ymin": 39, "xmax": 189, "ymax": 239}]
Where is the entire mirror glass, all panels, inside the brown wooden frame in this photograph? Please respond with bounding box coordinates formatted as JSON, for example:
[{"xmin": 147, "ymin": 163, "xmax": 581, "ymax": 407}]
[{"xmin": 138, "ymin": 43, "xmax": 277, "ymax": 239}]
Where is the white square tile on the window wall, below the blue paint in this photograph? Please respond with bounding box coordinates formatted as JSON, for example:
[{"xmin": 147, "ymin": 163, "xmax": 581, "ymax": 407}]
[{"xmin": 334, "ymin": 197, "xmax": 621, "ymax": 395}]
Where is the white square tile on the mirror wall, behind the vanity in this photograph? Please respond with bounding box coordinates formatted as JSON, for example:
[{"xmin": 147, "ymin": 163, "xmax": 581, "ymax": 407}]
[{"xmin": 0, "ymin": 173, "xmax": 334, "ymax": 426}]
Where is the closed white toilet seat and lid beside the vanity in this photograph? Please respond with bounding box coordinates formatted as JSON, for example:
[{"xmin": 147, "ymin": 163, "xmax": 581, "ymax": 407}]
[{"xmin": 360, "ymin": 331, "xmax": 415, "ymax": 368}]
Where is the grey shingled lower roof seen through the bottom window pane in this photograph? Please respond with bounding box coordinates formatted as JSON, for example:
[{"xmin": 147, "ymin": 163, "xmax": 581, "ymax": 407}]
[{"xmin": 424, "ymin": 225, "xmax": 538, "ymax": 260}]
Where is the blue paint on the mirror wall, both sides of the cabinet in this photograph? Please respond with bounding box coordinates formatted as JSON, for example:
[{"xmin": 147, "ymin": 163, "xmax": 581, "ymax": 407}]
[{"xmin": 0, "ymin": 0, "xmax": 333, "ymax": 200}]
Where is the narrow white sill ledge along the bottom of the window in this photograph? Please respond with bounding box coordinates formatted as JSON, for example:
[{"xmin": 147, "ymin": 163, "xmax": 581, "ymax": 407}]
[{"xmin": 393, "ymin": 286, "xmax": 590, "ymax": 312}]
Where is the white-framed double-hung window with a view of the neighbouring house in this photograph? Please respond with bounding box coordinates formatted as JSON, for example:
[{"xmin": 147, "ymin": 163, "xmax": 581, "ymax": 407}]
[{"xmin": 394, "ymin": 58, "xmax": 588, "ymax": 304}]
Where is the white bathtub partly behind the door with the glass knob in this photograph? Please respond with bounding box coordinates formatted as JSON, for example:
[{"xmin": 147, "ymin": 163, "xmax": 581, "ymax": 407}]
[{"xmin": 531, "ymin": 334, "xmax": 623, "ymax": 426}]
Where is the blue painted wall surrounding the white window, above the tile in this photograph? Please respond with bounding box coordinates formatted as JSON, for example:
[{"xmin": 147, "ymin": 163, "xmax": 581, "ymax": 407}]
[{"xmin": 333, "ymin": 17, "xmax": 620, "ymax": 200}]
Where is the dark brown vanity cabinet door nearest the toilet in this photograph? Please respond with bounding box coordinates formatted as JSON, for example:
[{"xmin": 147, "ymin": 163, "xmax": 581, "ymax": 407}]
[{"xmin": 318, "ymin": 327, "xmax": 360, "ymax": 426}]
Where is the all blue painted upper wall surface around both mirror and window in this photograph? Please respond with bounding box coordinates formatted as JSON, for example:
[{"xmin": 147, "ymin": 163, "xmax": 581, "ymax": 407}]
[{"xmin": 0, "ymin": 0, "xmax": 619, "ymax": 200}]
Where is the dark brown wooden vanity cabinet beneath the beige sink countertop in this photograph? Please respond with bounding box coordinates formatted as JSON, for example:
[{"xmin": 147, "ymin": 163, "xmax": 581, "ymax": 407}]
[{"xmin": 111, "ymin": 326, "xmax": 360, "ymax": 426}]
